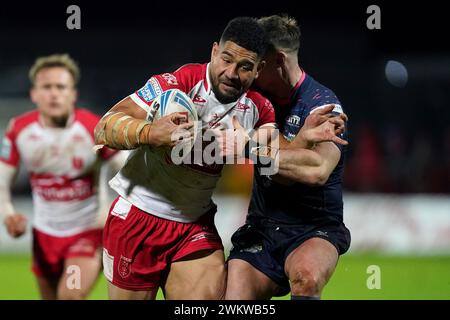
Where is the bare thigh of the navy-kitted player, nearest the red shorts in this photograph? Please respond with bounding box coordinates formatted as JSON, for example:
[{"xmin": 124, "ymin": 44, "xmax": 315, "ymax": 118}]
[{"xmin": 225, "ymin": 259, "xmax": 278, "ymax": 300}]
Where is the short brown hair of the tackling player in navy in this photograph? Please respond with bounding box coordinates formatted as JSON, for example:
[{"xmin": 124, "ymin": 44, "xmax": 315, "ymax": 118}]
[{"xmin": 258, "ymin": 14, "xmax": 300, "ymax": 52}]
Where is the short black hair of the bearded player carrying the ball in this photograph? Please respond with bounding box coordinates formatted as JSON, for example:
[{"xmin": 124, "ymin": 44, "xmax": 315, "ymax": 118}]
[{"xmin": 220, "ymin": 17, "xmax": 269, "ymax": 58}]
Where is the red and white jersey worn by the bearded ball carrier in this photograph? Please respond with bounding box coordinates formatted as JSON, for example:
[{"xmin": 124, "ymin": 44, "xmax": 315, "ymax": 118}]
[{"xmin": 110, "ymin": 64, "xmax": 275, "ymax": 222}]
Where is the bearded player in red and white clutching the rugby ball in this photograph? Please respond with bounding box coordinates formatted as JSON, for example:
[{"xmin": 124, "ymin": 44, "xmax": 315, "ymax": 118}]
[{"xmin": 96, "ymin": 18, "xmax": 275, "ymax": 299}]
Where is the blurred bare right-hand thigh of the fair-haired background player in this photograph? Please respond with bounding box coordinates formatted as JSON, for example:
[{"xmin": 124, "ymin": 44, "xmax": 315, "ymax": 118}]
[{"xmin": 58, "ymin": 251, "xmax": 102, "ymax": 300}]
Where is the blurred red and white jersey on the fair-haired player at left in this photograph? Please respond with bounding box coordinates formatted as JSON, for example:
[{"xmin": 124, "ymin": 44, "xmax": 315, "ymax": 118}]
[{"xmin": 0, "ymin": 109, "xmax": 116, "ymax": 237}]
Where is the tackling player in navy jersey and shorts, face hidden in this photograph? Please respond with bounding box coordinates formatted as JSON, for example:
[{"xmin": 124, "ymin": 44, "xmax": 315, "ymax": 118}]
[{"xmin": 226, "ymin": 16, "xmax": 350, "ymax": 300}]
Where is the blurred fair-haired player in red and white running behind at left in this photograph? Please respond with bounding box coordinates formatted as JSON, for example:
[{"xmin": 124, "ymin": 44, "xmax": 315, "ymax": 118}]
[{"xmin": 0, "ymin": 55, "xmax": 124, "ymax": 299}]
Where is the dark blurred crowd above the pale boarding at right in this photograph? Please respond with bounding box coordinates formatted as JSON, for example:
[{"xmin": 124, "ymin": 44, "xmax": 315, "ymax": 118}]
[{"xmin": 344, "ymin": 124, "xmax": 450, "ymax": 193}]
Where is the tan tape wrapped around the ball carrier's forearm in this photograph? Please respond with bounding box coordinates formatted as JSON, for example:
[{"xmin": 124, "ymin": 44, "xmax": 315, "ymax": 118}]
[{"xmin": 95, "ymin": 112, "xmax": 151, "ymax": 149}]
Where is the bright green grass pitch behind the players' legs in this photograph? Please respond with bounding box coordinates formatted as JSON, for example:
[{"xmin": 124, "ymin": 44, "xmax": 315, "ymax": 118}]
[{"xmin": 0, "ymin": 254, "xmax": 450, "ymax": 300}]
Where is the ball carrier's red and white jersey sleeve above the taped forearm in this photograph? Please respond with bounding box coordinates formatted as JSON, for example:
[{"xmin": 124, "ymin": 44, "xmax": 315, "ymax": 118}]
[{"xmin": 130, "ymin": 64, "xmax": 203, "ymax": 113}]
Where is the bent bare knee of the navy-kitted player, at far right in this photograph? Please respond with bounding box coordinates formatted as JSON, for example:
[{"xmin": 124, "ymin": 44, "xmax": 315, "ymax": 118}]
[{"xmin": 285, "ymin": 238, "xmax": 339, "ymax": 290}]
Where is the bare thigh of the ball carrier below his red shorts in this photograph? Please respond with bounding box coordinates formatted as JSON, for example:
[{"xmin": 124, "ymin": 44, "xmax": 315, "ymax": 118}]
[{"xmin": 164, "ymin": 249, "xmax": 226, "ymax": 300}]
